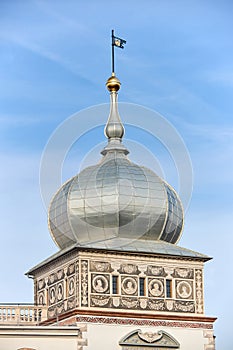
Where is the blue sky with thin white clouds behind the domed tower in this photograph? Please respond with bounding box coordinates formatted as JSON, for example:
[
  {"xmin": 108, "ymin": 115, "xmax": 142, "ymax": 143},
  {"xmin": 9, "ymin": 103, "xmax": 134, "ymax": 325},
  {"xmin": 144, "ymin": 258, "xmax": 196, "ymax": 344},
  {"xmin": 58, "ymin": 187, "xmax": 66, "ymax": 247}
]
[{"xmin": 0, "ymin": 0, "xmax": 233, "ymax": 350}]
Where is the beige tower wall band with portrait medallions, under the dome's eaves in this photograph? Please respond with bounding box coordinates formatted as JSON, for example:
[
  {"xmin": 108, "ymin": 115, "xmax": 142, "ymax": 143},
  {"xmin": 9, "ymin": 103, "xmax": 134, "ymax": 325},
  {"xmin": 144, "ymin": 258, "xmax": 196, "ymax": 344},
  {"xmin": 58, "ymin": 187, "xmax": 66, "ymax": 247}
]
[{"xmin": 34, "ymin": 252, "xmax": 204, "ymax": 318}]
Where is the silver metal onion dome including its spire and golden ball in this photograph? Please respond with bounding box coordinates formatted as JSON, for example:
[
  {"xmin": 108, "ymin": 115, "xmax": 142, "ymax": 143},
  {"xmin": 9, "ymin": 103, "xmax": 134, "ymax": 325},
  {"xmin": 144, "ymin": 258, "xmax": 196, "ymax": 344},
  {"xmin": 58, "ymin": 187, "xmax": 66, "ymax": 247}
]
[{"xmin": 49, "ymin": 73, "xmax": 183, "ymax": 250}]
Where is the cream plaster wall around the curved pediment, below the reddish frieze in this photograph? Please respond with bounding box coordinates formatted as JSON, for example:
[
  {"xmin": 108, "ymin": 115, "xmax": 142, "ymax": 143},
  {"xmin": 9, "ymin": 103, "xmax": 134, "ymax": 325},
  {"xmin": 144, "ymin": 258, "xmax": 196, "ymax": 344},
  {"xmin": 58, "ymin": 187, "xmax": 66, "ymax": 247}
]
[{"xmin": 84, "ymin": 324, "xmax": 207, "ymax": 350}]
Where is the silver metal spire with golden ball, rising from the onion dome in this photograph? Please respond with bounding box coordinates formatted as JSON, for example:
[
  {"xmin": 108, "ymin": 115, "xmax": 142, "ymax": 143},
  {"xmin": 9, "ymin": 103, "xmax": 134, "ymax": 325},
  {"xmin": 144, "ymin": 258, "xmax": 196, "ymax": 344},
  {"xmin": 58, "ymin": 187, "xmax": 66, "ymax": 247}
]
[{"xmin": 101, "ymin": 73, "xmax": 129, "ymax": 155}]
